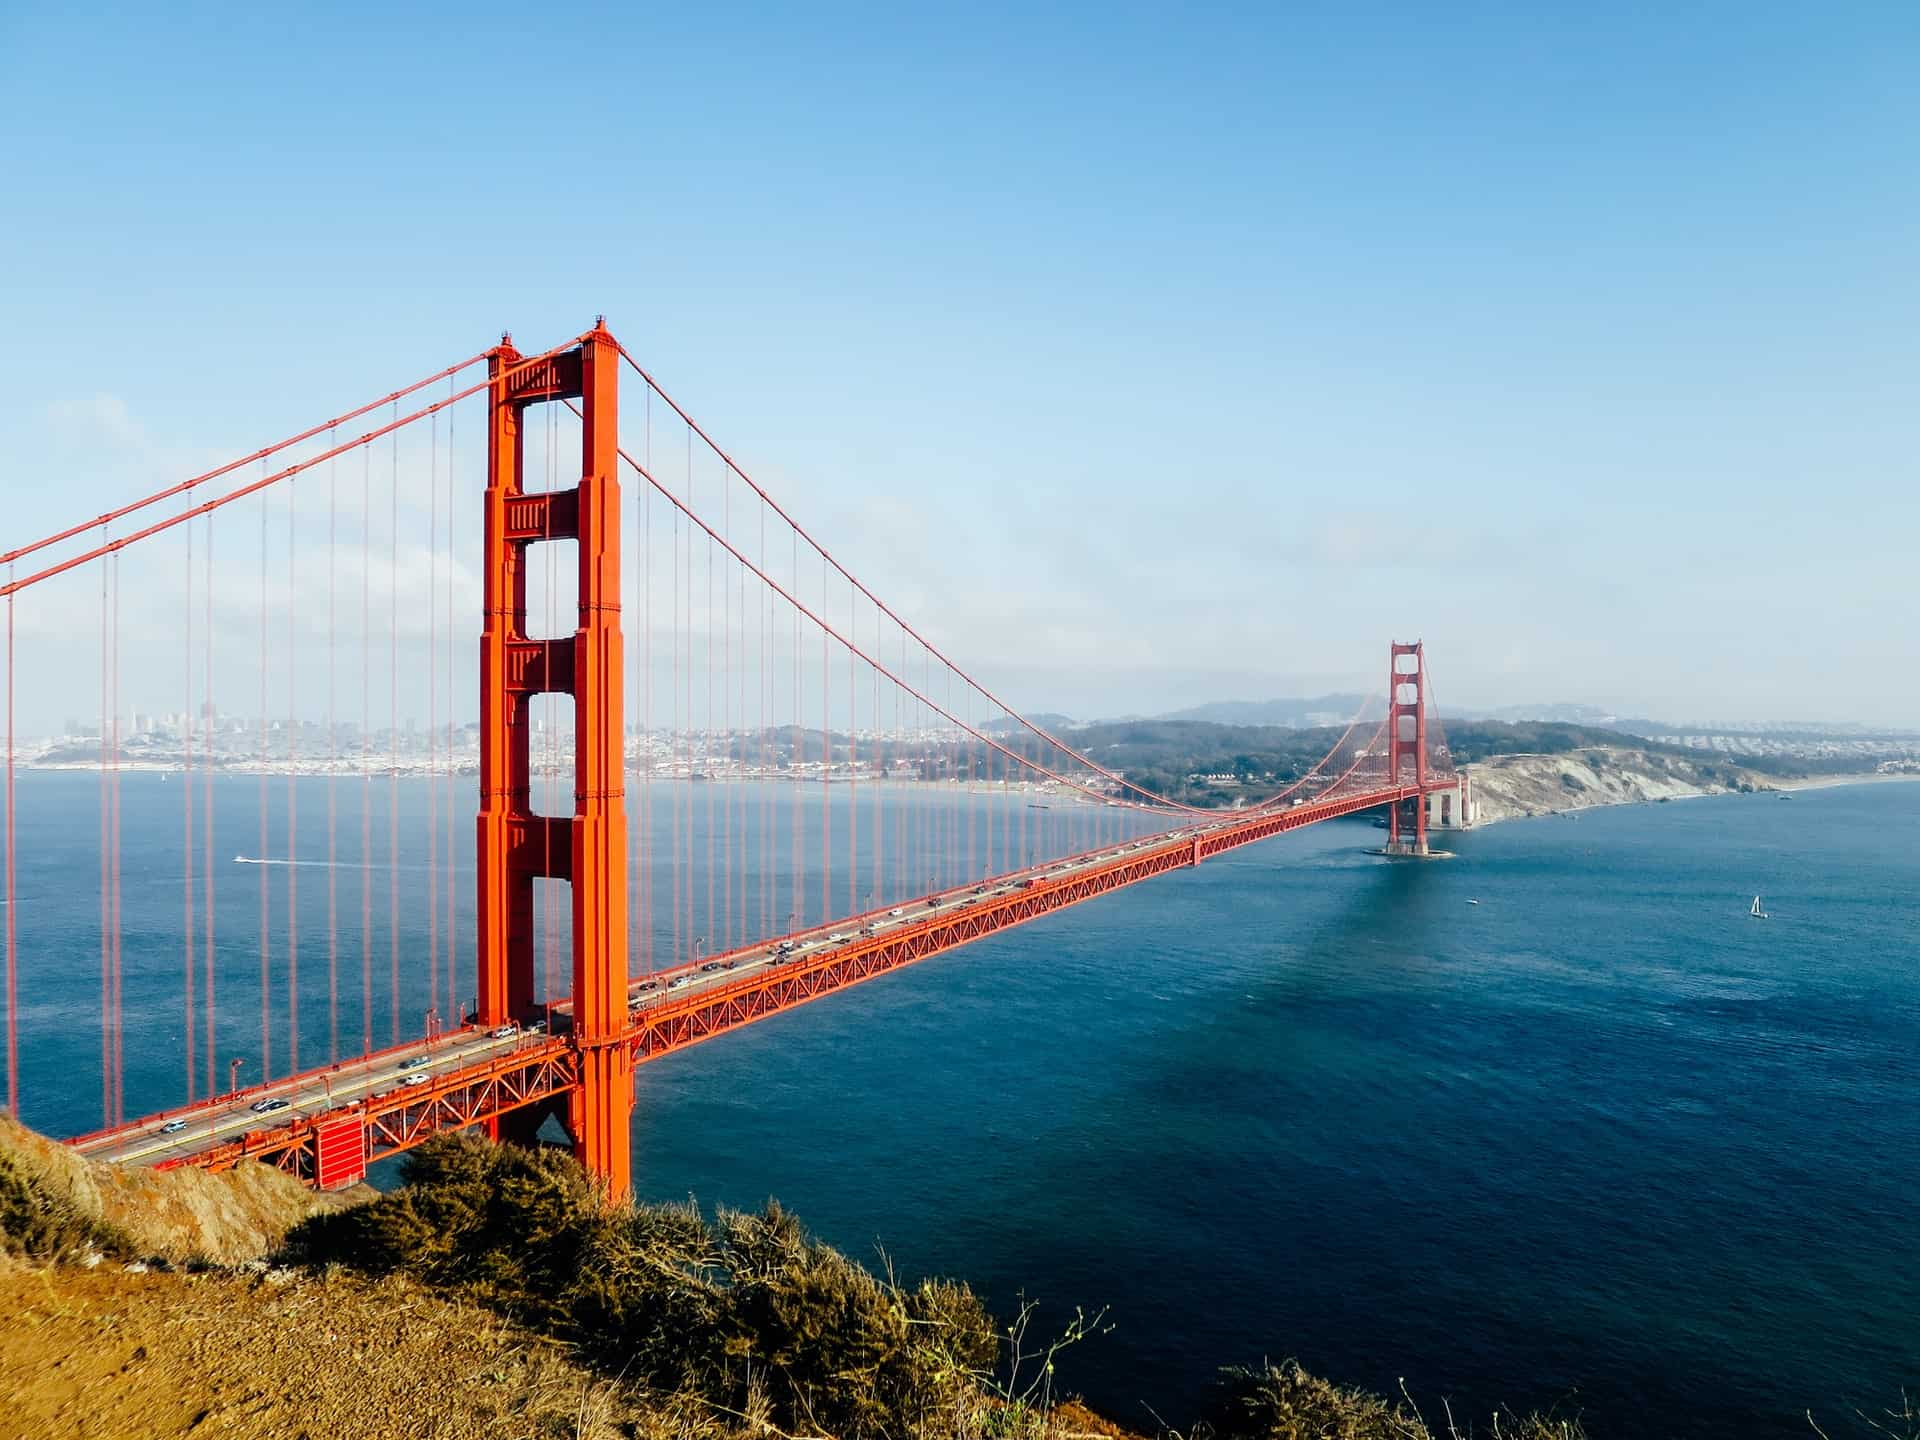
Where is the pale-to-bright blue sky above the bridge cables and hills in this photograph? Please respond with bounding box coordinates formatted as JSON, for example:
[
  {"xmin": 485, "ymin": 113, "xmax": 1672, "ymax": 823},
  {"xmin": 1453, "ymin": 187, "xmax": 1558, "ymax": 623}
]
[{"xmin": 0, "ymin": 4, "xmax": 1920, "ymax": 726}]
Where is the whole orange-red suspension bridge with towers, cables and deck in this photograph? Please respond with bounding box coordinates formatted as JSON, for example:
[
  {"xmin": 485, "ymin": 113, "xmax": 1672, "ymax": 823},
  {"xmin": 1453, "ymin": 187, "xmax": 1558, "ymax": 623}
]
[{"xmin": 0, "ymin": 324, "xmax": 1459, "ymax": 1194}]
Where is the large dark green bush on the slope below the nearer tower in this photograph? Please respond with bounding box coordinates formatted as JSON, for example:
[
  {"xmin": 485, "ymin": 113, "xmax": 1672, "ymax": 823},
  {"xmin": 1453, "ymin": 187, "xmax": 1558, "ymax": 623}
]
[{"xmin": 290, "ymin": 1135, "xmax": 998, "ymax": 1440}]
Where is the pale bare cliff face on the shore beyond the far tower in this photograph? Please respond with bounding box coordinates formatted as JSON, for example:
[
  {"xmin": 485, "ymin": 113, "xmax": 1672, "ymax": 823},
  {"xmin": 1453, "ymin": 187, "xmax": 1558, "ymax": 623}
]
[{"xmin": 1463, "ymin": 749, "xmax": 1774, "ymax": 826}]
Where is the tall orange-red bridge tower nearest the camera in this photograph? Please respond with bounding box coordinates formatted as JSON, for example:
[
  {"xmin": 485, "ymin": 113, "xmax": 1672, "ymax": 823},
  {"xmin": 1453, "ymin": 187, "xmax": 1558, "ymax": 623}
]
[{"xmin": 476, "ymin": 324, "xmax": 634, "ymax": 1198}]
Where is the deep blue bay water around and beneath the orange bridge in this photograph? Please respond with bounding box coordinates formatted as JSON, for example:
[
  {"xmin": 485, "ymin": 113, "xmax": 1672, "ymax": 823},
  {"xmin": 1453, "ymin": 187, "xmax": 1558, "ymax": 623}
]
[{"xmin": 17, "ymin": 774, "xmax": 1920, "ymax": 1436}]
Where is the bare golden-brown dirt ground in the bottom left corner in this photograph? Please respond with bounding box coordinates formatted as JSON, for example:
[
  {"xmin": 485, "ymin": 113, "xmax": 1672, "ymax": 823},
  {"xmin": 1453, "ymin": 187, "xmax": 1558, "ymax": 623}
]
[{"xmin": 0, "ymin": 1260, "xmax": 660, "ymax": 1440}]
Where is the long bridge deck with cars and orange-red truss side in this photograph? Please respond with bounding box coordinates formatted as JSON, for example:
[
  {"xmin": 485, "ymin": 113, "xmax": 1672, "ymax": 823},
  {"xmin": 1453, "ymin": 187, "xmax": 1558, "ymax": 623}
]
[{"xmin": 69, "ymin": 780, "xmax": 1453, "ymax": 1177}]
